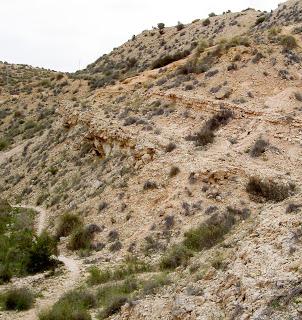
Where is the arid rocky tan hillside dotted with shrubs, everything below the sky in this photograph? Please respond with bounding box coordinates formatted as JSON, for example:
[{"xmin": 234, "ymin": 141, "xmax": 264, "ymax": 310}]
[{"xmin": 0, "ymin": 0, "xmax": 302, "ymax": 320}]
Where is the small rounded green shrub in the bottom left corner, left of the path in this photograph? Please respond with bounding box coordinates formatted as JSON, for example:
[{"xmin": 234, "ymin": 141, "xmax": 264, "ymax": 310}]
[{"xmin": 1, "ymin": 288, "xmax": 35, "ymax": 311}]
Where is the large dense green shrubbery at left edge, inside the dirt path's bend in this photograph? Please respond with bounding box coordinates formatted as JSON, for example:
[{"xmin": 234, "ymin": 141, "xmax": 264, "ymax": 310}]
[{"xmin": 0, "ymin": 201, "xmax": 57, "ymax": 282}]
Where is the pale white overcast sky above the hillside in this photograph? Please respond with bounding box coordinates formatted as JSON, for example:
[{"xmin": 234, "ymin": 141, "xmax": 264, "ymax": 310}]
[{"xmin": 0, "ymin": 0, "xmax": 283, "ymax": 71}]
